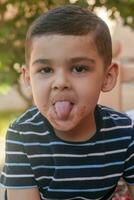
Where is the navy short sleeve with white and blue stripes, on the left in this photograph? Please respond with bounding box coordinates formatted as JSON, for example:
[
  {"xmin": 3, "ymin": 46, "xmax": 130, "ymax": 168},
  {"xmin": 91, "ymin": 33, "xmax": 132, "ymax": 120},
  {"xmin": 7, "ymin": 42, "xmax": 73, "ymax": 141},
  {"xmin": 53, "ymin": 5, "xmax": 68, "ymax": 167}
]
[{"xmin": 0, "ymin": 122, "xmax": 37, "ymax": 188}]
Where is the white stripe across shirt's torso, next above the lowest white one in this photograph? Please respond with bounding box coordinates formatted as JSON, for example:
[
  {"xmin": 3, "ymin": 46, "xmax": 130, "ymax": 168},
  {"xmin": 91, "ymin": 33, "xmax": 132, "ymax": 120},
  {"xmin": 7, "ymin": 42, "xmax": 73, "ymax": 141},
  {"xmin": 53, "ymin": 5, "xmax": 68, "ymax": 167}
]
[{"xmin": 28, "ymin": 149, "xmax": 127, "ymax": 158}]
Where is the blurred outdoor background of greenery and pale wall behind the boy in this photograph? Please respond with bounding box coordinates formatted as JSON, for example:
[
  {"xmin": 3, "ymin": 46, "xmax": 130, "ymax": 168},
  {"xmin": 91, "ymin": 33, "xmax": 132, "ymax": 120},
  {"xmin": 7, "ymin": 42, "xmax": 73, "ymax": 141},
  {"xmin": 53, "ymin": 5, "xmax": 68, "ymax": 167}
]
[{"xmin": 0, "ymin": 0, "xmax": 134, "ymax": 200}]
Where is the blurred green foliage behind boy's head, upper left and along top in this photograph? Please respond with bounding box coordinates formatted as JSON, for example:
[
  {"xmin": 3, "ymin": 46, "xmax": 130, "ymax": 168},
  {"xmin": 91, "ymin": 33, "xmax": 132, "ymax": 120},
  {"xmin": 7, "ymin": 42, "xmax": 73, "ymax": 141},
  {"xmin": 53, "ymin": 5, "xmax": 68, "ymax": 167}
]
[{"xmin": 0, "ymin": 0, "xmax": 134, "ymax": 91}]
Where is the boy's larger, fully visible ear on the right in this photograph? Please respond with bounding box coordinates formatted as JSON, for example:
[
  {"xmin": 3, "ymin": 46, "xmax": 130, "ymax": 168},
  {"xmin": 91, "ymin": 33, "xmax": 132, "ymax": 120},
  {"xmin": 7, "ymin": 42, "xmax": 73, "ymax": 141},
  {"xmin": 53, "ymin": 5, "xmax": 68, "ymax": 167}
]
[{"xmin": 101, "ymin": 63, "xmax": 119, "ymax": 92}]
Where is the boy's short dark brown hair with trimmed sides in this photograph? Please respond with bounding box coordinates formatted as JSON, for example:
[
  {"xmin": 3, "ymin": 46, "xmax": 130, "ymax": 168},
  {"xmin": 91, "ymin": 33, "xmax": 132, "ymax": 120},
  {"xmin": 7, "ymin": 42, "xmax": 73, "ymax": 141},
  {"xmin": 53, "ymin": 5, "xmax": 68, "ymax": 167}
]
[{"xmin": 25, "ymin": 5, "xmax": 112, "ymax": 66}]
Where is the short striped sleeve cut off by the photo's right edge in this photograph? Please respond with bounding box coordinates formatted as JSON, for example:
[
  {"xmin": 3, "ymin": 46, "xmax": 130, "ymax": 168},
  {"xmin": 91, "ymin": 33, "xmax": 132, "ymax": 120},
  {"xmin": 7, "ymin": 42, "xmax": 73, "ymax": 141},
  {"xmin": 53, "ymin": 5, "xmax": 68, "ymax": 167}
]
[{"xmin": 123, "ymin": 128, "xmax": 134, "ymax": 185}]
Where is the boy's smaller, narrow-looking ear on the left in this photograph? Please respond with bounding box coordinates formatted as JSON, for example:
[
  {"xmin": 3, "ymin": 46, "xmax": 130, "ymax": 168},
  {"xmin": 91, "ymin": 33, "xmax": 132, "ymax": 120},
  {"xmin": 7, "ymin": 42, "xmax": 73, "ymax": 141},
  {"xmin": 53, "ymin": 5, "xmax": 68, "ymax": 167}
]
[{"xmin": 21, "ymin": 66, "xmax": 30, "ymax": 87}]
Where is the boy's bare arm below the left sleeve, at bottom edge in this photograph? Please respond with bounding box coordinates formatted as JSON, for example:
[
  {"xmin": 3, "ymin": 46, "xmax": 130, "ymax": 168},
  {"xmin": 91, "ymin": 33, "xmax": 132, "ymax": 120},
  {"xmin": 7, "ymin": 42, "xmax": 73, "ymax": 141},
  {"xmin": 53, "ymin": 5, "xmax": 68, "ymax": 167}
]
[{"xmin": 7, "ymin": 188, "xmax": 40, "ymax": 200}]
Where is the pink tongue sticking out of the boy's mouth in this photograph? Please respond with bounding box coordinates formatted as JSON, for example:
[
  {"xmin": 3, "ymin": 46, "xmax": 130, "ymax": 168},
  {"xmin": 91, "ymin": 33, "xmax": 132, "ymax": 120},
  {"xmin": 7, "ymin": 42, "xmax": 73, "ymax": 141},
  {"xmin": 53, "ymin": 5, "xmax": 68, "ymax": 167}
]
[{"xmin": 55, "ymin": 101, "xmax": 72, "ymax": 119}]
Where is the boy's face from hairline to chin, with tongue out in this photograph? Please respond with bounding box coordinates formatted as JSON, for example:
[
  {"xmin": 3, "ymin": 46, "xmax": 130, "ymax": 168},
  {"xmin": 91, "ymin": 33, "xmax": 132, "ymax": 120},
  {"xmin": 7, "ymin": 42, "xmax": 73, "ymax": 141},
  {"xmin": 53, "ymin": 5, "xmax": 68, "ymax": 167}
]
[{"xmin": 24, "ymin": 35, "xmax": 116, "ymax": 138}]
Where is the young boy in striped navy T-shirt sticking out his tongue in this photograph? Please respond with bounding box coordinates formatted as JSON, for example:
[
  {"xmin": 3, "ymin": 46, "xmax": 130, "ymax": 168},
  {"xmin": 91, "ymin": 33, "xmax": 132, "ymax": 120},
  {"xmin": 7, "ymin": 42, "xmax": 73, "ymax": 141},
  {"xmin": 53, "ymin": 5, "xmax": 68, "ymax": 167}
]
[{"xmin": 1, "ymin": 5, "xmax": 134, "ymax": 200}]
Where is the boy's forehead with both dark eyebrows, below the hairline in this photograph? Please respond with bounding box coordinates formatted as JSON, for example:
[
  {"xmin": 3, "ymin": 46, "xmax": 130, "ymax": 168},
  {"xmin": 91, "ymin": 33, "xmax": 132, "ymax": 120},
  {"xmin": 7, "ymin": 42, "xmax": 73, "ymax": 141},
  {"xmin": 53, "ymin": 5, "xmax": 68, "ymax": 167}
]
[{"xmin": 30, "ymin": 34, "xmax": 102, "ymax": 68}]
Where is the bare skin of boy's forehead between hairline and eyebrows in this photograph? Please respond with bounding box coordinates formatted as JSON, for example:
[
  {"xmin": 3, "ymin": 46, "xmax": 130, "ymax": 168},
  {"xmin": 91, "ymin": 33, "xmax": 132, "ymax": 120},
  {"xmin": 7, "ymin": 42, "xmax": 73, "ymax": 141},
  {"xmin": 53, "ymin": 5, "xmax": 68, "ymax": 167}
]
[{"xmin": 31, "ymin": 34, "xmax": 97, "ymax": 52}]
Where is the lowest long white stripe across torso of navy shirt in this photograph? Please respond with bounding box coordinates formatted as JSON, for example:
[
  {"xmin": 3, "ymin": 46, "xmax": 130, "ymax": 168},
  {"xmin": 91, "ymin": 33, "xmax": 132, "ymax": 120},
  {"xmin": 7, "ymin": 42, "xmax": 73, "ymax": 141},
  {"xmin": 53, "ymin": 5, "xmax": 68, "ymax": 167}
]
[{"xmin": 36, "ymin": 173, "xmax": 122, "ymax": 182}]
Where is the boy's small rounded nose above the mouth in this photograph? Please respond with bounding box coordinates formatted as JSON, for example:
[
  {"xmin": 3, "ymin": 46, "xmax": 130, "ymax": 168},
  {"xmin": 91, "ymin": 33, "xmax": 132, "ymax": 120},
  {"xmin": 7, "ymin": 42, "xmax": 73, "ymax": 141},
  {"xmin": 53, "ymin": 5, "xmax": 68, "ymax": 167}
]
[{"xmin": 52, "ymin": 74, "xmax": 71, "ymax": 90}]
